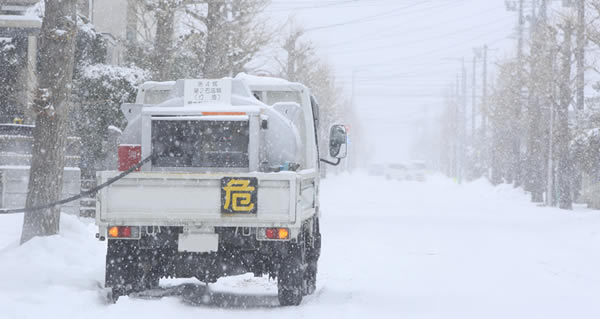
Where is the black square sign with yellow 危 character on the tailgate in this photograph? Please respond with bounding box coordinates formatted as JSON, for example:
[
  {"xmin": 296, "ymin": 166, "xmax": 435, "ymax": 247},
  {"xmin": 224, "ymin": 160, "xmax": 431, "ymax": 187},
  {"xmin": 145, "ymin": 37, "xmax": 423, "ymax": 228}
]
[{"xmin": 221, "ymin": 177, "xmax": 258, "ymax": 214}]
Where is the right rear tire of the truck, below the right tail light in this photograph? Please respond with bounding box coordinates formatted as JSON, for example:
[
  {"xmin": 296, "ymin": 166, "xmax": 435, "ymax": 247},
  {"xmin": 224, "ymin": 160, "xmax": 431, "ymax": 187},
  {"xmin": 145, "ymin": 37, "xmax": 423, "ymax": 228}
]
[{"xmin": 277, "ymin": 245, "xmax": 306, "ymax": 306}]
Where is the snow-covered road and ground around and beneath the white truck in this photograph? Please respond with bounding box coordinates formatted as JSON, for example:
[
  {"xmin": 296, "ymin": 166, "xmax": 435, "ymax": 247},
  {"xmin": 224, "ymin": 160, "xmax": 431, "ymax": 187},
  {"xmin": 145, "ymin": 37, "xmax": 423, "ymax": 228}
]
[{"xmin": 0, "ymin": 174, "xmax": 600, "ymax": 319}]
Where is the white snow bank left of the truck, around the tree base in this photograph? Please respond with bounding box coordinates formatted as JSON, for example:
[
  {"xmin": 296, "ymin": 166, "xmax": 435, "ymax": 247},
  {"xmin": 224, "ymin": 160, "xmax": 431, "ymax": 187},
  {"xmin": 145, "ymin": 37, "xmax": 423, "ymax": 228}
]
[{"xmin": 0, "ymin": 214, "xmax": 105, "ymax": 318}]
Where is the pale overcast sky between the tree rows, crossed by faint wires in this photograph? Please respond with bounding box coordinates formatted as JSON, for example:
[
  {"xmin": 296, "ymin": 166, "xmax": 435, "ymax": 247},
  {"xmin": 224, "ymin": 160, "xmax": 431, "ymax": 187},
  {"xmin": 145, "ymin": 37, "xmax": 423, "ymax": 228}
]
[{"xmin": 268, "ymin": 0, "xmax": 516, "ymax": 162}]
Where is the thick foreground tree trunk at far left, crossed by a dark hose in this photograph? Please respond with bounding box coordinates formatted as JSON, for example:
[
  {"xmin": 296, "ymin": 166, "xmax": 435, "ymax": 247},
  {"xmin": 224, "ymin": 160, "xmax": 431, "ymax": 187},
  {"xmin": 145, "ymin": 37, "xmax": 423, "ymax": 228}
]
[{"xmin": 21, "ymin": 0, "xmax": 77, "ymax": 243}]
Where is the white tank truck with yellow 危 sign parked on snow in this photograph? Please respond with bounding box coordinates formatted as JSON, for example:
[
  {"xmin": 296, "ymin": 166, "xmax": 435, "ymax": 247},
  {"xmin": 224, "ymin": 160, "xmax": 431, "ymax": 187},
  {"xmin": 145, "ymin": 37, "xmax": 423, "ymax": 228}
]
[{"xmin": 96, "ymin": 75, "xmax": 347, "ymax": 305}]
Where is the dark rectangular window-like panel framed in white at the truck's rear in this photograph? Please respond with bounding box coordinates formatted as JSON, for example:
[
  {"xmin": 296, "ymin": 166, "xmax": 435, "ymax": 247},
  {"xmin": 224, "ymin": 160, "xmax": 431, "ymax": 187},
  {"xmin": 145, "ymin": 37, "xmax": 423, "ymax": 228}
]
[{"xmin": 152, "ymin": 120, "xmax": 249, "ymax": 168}]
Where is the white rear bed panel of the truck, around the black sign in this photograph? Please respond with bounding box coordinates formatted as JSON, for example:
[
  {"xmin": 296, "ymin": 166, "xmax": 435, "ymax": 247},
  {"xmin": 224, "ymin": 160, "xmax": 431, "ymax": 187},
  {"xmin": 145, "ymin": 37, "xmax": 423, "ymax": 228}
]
[{"xmin": 96, "ymin": 171, "xmax": 300, "ymax": 227}]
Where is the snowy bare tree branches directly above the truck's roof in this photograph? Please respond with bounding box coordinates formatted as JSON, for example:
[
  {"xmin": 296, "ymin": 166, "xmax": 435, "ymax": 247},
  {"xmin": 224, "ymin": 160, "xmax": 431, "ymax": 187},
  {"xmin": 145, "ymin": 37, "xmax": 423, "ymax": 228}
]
[{"xmin": 134, "ymin": 0, "xmax": 272, "ymax": 80}]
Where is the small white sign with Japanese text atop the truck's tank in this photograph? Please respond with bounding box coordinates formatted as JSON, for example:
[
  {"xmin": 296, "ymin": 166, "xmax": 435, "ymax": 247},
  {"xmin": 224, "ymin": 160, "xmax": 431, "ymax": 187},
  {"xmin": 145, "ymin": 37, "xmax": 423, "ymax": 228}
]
[{"xmin": 183, "ymin": 79, "xmax": 231, "ymax": 105}]
